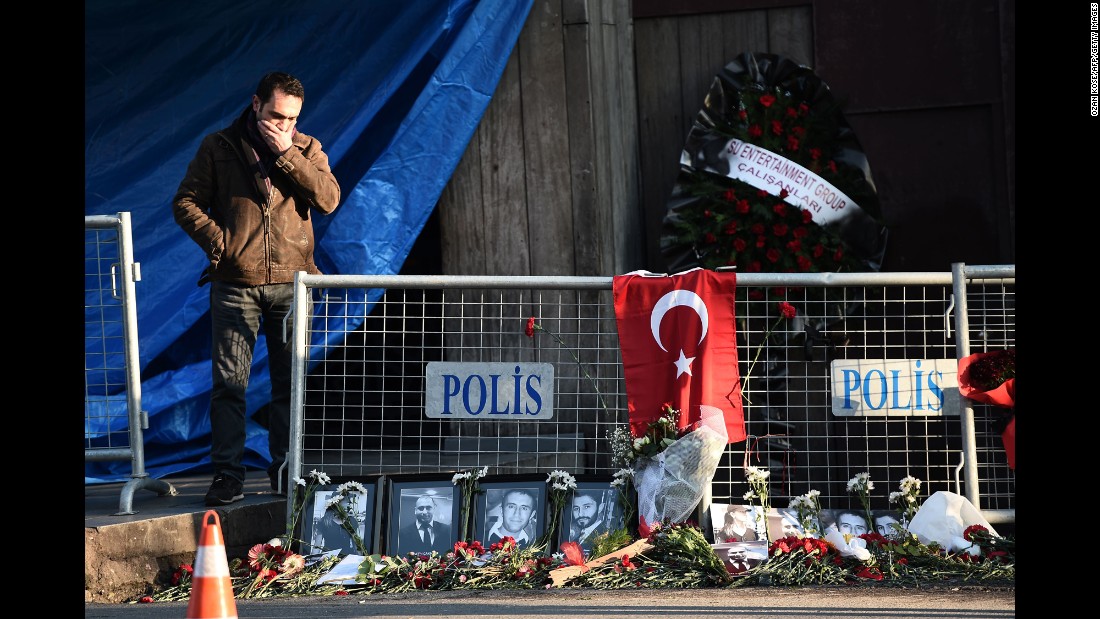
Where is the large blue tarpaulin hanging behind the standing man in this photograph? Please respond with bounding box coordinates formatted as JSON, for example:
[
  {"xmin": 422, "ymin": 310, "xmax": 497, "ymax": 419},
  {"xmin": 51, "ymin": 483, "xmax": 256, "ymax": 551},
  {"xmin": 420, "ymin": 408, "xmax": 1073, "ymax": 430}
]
[{"xmin": 85, "ymin": 0, "xmax": 531, "ymax": 483}]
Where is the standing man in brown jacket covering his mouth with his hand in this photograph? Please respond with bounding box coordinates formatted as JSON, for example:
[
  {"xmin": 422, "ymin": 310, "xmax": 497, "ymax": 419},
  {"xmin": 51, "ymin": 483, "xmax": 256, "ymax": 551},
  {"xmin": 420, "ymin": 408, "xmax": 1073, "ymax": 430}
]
[{"xmin": 173, "ymin": 71, "xmax": 340, "ymax": 506}]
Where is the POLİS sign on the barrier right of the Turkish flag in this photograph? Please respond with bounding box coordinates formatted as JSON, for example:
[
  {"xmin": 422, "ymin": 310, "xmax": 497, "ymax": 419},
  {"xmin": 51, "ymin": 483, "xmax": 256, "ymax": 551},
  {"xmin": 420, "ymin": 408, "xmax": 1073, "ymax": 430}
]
[{"xmin": 832, "ymin": 358, "xmax": 960, "ymax": 417}]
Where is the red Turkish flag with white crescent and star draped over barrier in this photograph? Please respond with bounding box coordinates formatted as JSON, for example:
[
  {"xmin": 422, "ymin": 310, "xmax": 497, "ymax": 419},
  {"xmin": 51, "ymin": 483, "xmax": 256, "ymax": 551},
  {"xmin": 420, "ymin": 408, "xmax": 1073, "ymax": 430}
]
[{"xmin": 613, "ymin": 268, "xmax": 745, "ymax": 443}]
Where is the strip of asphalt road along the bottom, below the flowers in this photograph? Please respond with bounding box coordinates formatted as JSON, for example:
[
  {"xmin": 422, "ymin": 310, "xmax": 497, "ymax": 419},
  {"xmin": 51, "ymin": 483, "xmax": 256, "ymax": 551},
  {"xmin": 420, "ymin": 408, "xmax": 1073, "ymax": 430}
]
[{"xmin": 84, "ymin": 586, "xmax": 1016, "ymax": 619}]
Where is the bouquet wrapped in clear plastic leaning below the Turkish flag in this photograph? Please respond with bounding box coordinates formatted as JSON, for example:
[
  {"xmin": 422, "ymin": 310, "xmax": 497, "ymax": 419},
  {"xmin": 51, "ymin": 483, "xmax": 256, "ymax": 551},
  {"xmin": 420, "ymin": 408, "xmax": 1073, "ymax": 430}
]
[{"xmin": 634, "ymin": 405, "xmax": 727, "ymax": 522}]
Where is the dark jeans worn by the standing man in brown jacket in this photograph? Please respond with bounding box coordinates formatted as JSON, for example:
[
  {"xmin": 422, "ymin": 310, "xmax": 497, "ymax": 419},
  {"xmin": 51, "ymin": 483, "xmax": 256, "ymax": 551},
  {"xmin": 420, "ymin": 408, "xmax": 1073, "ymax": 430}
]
[{"xmin": 210, "ymin": 281, "xmax": 294, "ymax": 482}]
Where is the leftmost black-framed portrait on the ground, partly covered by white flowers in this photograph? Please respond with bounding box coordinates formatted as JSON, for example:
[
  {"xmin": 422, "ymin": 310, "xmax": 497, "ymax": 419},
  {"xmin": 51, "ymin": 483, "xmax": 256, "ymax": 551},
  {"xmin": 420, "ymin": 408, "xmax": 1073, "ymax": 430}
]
[{"xmin": 300, "ymin": 477, "xmax": 380, "ymax": 555}]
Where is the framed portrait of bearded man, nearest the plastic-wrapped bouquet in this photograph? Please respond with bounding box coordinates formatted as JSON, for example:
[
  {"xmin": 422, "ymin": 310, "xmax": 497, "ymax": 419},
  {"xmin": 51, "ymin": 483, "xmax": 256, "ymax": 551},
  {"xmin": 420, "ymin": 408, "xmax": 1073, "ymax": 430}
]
[{"xmin": 557, "ymin": 477, "xmax": 628, "ymax": 559}]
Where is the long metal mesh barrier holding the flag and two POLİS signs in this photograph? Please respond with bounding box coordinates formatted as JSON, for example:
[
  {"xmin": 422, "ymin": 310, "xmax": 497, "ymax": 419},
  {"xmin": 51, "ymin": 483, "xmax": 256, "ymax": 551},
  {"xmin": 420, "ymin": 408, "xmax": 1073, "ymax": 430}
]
[{"xmin": 288, "ymin": 266, "xmax": 1015, "ymax": 522}]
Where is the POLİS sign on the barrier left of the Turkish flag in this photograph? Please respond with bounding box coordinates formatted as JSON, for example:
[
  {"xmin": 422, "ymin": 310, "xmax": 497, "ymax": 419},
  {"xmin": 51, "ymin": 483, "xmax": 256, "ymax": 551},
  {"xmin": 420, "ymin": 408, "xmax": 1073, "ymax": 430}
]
[{"xmin": 424, "ymin": 362, "xmax": 553, "ymax": 421}]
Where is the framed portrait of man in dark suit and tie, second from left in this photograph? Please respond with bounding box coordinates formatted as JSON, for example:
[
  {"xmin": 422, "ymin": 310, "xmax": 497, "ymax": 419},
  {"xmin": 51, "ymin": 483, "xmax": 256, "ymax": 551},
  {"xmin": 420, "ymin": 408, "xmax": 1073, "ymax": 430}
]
[{"xmin": 386, "ymin": 473, "xmax": 462, "ymax": 556}]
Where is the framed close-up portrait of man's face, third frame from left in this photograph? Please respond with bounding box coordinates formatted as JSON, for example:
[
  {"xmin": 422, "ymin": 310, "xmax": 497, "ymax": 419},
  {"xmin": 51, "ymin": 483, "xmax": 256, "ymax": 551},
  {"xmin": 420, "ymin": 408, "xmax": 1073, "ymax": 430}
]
[{"xmin": 474, "ymin": 475, "xmax": 547, "ymax": 549}]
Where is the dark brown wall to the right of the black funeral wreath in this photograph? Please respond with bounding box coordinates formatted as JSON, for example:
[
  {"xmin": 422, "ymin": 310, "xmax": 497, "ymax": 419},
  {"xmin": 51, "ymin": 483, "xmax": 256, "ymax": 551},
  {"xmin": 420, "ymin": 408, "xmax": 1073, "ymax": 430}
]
[{"xmin": 814, "ymin": 0, "xmax": 1015, "ymax": 270}]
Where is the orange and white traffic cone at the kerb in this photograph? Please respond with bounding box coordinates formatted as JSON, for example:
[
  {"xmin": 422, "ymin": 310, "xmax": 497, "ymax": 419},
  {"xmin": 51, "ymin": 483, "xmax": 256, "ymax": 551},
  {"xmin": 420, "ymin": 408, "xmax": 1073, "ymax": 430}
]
[{"xmin": 187, "ymin": 509, "xmax": 237, "ymax": 619}]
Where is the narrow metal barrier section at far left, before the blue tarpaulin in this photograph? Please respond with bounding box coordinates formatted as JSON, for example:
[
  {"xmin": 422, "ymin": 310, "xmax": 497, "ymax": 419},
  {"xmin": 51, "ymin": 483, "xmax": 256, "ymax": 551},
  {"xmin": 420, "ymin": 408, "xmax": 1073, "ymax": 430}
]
[{"xmin": 84, "ymin": 212, "xmax": 176, "ymax": 516}]
